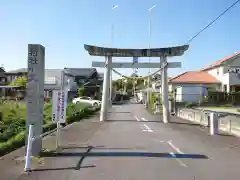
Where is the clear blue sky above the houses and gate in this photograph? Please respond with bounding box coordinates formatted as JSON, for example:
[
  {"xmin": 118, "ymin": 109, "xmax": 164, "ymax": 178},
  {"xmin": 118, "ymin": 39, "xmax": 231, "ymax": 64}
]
[{"xmin": 0, "ymin": 0, "xmax": 240, "ymax": 78}]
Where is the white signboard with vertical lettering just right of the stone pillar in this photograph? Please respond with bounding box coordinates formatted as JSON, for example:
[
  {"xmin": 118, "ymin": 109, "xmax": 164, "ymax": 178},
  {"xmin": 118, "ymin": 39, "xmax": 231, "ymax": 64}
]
[{"xmin": 52, "ymin": 90, "xmax": 67, "ymax": 123}]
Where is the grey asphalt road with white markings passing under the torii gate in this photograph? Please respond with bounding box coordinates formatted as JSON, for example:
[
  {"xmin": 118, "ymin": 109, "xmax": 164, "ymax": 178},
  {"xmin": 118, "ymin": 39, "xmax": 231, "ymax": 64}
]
[{"xmin": 19, "ymin": 104, "xmax": 240, "ymax": 180}]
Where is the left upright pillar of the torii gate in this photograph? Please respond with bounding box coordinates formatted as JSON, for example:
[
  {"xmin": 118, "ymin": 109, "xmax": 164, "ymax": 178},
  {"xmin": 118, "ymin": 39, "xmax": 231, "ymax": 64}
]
[{"xmin": 100, "ymin": 57, "xmax": 112, "ymax": 121}]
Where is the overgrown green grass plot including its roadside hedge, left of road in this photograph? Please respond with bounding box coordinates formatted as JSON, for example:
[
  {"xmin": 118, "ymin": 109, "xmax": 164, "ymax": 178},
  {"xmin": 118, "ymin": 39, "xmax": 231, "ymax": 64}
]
[{"xmin": 0, "ymin": 103, "xmax": 99, "ymax": 156}]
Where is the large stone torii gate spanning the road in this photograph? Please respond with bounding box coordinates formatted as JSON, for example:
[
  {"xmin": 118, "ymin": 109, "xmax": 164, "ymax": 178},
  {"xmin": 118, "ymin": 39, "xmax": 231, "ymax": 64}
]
[{"xmin": 84, "ymin": 44, "xmax": 189, "ymax": 123}]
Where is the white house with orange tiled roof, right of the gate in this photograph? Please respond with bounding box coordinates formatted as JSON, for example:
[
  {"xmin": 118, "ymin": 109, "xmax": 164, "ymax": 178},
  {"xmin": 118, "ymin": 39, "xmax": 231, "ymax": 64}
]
[{"xmin": 169, "ymin": 53, "xmax": 240, "ymax": 101}]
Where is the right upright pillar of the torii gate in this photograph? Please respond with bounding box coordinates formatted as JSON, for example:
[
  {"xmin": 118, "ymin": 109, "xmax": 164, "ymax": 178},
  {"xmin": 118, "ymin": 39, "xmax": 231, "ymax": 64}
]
[{"xmin": 160, "ymin": 56, "xmax": 169, "ymax": 123}]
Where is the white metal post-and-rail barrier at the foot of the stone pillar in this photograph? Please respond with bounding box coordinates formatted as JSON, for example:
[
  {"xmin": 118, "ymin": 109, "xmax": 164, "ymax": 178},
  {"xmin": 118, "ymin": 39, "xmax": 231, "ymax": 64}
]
[{"xmin": 24, "ymin": 123, "xmax": 61, "ymax": 171}]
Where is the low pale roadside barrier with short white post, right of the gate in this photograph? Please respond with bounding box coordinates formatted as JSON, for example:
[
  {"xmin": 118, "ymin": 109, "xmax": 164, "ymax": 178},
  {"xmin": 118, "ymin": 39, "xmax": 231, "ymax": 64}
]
[{"xmin": 177, "ymin": 108, "xmax": 240, "ymax": 136}]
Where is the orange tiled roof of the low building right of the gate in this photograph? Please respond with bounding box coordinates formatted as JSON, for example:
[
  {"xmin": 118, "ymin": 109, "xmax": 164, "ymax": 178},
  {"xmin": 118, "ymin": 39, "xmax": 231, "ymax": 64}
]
[{"xmin": 170, "ymin": 71, "xmax": 220, "ymax": 84}]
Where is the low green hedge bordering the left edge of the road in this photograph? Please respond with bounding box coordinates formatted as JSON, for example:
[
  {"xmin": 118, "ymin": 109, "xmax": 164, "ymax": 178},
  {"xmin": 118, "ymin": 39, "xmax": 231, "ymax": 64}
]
[{"xmin": 0, "ymin": 104, "xmax": 99, "ymax": 156}]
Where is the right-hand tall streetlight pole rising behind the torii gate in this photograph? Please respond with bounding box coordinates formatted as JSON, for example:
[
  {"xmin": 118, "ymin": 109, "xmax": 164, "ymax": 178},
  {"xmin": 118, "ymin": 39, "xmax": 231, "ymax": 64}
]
[{"xmin": 147, "ymin": 5, "xmax": 157, "ymax": 106}]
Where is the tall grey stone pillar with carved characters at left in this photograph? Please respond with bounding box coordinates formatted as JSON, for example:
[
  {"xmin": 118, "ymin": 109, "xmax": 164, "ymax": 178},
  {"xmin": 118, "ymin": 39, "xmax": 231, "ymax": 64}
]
[{"xmin": 26, "ymin": 44, "xmax": 45, "ymax": 155}]
